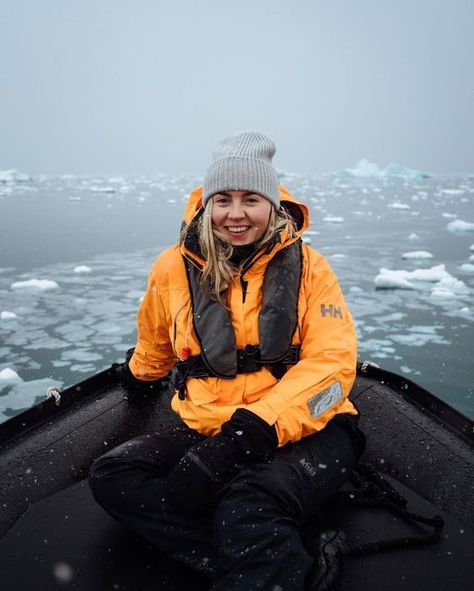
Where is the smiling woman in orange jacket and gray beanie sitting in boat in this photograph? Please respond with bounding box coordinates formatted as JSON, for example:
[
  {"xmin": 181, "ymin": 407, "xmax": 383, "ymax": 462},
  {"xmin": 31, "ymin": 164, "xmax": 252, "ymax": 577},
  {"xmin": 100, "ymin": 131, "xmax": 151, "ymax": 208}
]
[{"xmin": 90, "ymin": 131, "xmax": 364, "ymax": 591}]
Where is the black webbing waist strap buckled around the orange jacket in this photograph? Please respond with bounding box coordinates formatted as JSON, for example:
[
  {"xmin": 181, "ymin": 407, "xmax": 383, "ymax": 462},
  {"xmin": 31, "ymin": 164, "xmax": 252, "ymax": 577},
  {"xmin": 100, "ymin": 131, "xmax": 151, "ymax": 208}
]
[{"xmin": 171, "ymin": 345, "xmax": 301, "ymax": 400}]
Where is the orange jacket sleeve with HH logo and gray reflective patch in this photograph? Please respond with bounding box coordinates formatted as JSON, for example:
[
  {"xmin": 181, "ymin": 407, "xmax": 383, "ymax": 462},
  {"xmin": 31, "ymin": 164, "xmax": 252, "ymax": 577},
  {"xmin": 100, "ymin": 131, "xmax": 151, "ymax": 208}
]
[{"xmin": 247, "ymin": 248, "xmax": 357, "ymax": 445}]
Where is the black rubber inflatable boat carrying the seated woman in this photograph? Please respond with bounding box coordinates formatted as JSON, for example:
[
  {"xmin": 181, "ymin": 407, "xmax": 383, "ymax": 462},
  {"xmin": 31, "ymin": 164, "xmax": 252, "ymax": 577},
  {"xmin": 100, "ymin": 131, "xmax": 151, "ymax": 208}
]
[{"xmin": 0, "ymin": 364, "xmax": 474, "ymax": 591}]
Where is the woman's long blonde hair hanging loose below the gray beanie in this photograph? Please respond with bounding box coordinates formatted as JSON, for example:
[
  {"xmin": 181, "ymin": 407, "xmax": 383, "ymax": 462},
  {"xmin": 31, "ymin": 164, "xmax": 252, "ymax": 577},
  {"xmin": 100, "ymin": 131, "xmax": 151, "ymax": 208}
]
[{"xmin": 181, "ymin": 198, "xmax": 296, "ymax": 306}]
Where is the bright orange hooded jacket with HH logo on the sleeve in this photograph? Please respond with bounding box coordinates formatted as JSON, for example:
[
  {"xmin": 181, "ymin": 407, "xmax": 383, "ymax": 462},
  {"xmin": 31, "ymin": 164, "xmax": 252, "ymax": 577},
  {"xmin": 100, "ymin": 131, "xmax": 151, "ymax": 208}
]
[{"xmin": 129, "ymin": 185, "xmax": 357, "ymax": 445}]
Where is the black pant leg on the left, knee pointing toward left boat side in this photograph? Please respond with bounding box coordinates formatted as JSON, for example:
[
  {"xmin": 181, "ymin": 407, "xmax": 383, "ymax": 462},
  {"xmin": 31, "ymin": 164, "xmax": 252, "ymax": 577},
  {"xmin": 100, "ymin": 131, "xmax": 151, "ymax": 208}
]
[{"xmin": 89, "ymin": 426, "xmax": 214, "ymax": 574}]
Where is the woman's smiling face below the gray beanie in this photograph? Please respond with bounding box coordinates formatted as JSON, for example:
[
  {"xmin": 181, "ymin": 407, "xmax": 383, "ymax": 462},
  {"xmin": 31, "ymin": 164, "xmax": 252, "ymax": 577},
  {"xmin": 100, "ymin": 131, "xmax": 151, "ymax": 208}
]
[{"xmin": 211, "ymin": 191, "xmax": 273, "ymax": 246}]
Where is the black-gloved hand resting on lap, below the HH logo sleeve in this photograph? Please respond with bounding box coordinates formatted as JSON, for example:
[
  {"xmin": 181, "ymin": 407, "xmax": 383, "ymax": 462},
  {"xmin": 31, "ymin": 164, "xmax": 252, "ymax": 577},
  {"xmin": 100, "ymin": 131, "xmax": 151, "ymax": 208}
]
[{"xmin": 168, "ymin": 408, "xmax": 278, "ymax": 510}]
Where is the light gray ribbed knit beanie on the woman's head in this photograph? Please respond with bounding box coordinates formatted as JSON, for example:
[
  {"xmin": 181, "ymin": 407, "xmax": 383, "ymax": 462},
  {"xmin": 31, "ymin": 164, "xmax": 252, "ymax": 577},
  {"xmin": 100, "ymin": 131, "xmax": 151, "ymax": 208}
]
[{"xmin": 202, "ymin": 131, "xmax": 280, "ymax": 209}]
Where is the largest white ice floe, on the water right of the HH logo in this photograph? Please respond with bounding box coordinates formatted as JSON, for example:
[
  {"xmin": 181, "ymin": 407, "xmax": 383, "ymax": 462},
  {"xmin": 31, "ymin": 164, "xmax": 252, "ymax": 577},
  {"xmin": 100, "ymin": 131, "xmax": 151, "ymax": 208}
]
[{"xmin": 374, "ymin": 265, "xmax": 469, "ymax": 297}]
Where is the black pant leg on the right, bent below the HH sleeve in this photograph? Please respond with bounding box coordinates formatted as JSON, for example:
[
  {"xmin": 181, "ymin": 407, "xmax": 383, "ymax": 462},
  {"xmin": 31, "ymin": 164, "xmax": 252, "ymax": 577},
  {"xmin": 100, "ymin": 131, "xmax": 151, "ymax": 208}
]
[{"xmin": 212, "ymin": 421, "xmax": 360, "ymax": 591}]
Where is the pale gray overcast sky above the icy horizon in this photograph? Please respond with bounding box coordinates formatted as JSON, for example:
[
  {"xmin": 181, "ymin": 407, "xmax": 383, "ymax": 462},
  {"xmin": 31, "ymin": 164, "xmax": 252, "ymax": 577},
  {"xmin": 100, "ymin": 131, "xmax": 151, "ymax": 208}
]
[{"xmin": 0, "ymin": 0, "xmax": 474, "ymax": 174}]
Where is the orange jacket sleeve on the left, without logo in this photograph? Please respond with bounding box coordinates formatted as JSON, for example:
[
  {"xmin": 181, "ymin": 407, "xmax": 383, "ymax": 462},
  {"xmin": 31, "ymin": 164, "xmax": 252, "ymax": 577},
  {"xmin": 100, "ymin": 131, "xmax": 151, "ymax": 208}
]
[{"xmin": 129, "ymin": 258, "xmax": 175, "ymax": 381}]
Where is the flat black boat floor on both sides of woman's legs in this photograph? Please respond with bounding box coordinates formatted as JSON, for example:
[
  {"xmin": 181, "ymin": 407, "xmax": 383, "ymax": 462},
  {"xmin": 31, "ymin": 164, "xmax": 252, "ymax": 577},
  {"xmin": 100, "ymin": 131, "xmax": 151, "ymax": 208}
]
[{"xmin": 0, "ymin": 472, "xmax": 474, "ymax": 591}]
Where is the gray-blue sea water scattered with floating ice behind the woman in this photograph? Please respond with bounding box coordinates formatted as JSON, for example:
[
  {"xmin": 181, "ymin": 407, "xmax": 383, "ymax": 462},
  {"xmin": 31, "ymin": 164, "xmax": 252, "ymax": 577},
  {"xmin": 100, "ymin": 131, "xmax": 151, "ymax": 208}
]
[{"xmin": 0, "ymin": 161, "xmax": 474, "ymax": 420}]
